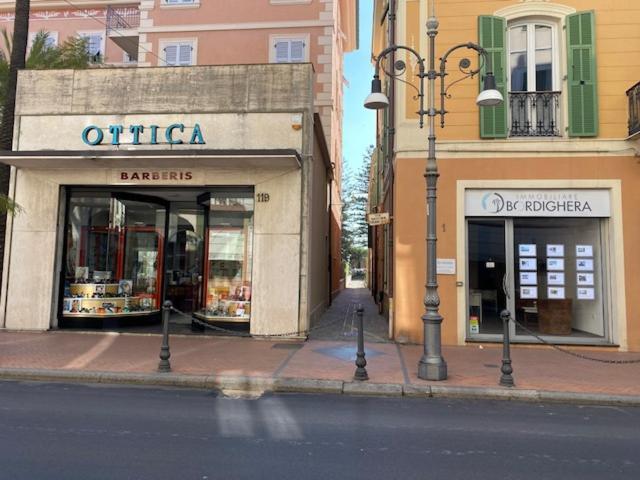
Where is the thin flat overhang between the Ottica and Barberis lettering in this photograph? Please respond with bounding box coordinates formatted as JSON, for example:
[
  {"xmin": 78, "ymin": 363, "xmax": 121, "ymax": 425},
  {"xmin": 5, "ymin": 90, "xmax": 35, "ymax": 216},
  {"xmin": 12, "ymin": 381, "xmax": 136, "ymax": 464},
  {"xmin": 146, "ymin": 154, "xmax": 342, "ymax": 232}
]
[{"xmin": 0, "ymin": 149, "xmax": 302, "ymax": 169}]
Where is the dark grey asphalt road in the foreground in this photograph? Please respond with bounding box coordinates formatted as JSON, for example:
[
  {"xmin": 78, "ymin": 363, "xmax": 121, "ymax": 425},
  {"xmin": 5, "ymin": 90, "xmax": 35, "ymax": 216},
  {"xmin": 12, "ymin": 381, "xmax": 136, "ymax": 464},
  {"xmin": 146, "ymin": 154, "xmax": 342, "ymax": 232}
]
[{"xmin": 0, "ymin": 382, "xmax": 640, "ymax": 480}]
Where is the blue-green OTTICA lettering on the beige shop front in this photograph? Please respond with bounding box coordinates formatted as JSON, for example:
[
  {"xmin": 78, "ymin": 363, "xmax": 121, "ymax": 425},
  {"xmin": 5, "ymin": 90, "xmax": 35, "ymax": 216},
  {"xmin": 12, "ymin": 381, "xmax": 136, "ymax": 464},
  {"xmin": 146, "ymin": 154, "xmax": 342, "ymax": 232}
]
[{"xmin": 82, "ymin": 123, "xmax": 206, "ymax": 147}]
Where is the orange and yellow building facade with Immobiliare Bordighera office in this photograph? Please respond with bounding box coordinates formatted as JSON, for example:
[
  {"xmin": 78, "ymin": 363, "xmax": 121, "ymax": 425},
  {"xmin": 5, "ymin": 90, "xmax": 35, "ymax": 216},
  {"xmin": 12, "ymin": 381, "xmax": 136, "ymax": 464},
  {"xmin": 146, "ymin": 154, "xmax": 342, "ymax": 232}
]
[{"xmin": 370, "ymin": 0, "xmax": 640, "ymax": 351}]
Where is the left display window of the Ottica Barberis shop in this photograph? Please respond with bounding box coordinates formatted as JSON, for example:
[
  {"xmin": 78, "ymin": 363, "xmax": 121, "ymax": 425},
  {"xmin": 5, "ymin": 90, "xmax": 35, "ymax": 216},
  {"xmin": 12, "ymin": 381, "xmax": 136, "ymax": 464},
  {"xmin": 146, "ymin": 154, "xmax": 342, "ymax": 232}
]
[{"xmin": 62, "ymin": 192, "xmax": 166, "ymax": 318}]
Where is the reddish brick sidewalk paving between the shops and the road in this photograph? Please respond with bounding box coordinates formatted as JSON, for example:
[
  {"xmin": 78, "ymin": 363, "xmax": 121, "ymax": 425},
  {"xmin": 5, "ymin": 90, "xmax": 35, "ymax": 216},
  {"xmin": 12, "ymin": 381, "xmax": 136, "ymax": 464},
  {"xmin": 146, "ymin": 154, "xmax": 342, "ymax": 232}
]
[{"xmin": 0, "ymin": 289, "xmax": 640, "ymax": 396}]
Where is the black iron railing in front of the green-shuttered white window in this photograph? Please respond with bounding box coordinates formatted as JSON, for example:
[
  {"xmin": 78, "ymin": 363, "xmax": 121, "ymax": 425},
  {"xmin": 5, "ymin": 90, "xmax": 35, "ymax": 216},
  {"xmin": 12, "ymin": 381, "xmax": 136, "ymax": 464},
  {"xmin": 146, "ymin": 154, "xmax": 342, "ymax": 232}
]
[{"xmin": 509, "ymin": 92, "xmax": 560, "ymax": 137}]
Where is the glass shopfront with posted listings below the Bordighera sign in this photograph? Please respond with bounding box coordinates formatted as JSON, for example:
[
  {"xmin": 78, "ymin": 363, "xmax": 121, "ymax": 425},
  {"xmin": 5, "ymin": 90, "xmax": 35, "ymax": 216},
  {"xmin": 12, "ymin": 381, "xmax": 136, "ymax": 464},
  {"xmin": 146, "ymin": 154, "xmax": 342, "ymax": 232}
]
[{"xmin": 467, "ymin": 218, "xmax": 609, "ymax": 343}]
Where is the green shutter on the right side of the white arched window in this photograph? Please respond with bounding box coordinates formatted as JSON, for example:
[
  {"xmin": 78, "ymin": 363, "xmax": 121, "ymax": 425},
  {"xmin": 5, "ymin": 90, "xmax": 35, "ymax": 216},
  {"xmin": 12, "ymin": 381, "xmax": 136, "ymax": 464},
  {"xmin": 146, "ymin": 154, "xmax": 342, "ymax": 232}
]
[{"xmin": 567, "ymin": 12, "xmax": 598, "ymax": 137}]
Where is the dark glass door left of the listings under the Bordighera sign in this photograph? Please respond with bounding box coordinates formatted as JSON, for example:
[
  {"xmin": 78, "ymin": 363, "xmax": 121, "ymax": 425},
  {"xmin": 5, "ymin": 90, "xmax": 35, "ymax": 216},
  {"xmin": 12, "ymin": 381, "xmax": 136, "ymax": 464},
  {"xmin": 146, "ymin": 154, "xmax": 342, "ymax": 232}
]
[{"xmin": 467, "ymin": 219, "xmax": 508, "ymax": 337}]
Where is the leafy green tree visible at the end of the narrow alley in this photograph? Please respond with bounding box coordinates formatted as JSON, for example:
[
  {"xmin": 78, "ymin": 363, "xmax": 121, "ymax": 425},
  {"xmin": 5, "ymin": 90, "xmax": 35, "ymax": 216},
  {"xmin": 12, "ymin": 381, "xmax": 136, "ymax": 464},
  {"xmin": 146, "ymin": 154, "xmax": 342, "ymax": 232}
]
[{"xmin": 341, "ymin": 145, "xmax": 374, "ymax": 268}]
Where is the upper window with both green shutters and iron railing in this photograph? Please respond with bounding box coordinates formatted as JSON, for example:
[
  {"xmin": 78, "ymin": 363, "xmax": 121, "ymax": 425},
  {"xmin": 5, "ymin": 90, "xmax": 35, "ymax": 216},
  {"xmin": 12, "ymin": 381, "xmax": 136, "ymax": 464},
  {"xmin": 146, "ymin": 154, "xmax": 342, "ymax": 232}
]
[{"xmin": 478, "ymin": 11, "xmax": 598, "ymax": 138}]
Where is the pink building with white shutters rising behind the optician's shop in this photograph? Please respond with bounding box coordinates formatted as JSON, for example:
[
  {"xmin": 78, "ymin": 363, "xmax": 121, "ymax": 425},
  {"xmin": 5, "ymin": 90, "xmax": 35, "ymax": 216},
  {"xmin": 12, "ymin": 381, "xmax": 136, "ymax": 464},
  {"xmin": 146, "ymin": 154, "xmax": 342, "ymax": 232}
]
[{"xmin": 0, "ymin": 0, "xmax": 357, "ymax": 300}]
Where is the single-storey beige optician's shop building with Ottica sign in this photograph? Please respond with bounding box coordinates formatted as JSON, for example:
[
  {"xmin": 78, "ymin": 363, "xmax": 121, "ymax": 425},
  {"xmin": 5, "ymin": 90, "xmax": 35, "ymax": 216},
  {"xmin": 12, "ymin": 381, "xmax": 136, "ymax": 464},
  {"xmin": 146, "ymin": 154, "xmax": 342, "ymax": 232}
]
[{"xmin": 0, "ymin": 64, "xmax": 332, "ymax": 336}]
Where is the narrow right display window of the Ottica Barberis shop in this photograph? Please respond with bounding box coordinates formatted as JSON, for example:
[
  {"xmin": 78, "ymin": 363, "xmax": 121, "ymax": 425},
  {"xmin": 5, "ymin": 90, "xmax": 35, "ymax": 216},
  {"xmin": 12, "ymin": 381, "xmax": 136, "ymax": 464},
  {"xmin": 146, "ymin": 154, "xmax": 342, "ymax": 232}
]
[{"xmin": 198, "ymin": 189, "xmax": 254, "ymax": 322}]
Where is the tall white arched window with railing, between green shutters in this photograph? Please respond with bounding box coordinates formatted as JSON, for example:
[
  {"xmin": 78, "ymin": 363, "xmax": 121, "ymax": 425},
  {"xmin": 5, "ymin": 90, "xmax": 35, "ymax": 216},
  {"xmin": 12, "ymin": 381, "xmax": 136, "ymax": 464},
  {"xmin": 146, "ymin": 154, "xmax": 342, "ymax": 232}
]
[{"xmin": 507, "ymin": 22, "xmax": 560, "ymax": 137}]
